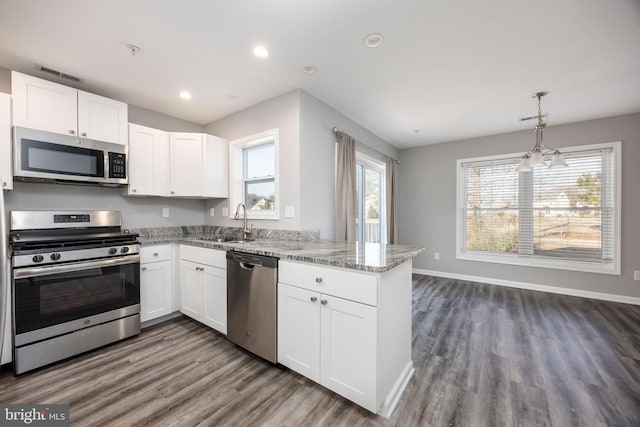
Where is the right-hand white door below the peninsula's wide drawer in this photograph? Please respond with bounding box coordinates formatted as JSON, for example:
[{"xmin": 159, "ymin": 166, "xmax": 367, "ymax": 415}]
[{"xmin": 320, "ymin": 295, "xmax": 378, "ymax": 412}]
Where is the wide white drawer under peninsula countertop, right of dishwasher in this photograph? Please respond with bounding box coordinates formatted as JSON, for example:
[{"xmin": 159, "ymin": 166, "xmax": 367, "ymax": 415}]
[{"xmin": 278, "ymin": 261, "xmax": 378, "ymax": 306}]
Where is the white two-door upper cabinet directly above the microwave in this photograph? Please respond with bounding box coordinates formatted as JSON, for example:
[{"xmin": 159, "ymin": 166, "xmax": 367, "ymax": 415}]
[{"xmin": 11, "ymin": 71, "xmax": 128, "ymax": 145}]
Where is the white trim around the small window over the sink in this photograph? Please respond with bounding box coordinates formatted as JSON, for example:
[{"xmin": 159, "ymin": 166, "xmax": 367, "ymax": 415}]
[{"xmin": 229, "ymin": 128, "xmax": 280, "ymax": 220}]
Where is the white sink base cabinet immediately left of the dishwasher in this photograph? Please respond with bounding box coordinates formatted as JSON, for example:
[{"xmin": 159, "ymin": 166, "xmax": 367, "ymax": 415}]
[{"xmin": 180, "ymin": 245, "xmax": 227, "ymax": 334}]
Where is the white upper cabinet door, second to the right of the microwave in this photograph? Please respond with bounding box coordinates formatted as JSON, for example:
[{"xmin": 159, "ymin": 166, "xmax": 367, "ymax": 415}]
[{"xmin": 169, "ymin": 132, "xmax": 203, "ymax": 197}]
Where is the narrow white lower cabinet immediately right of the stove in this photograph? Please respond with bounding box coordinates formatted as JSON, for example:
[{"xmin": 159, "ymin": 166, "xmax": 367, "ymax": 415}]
[{"xmin": 140, "ymin": 245, "xmax": 173, "ymax": 322}]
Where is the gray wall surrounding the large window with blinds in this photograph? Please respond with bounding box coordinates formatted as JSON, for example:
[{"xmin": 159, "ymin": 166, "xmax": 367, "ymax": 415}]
[{"xmin": 399, "ymin": 113, "xmax": 640, "ymax": 297}]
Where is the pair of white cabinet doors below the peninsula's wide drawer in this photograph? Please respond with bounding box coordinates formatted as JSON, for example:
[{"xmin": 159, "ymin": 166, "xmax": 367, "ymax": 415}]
[{"xmin": 278, "ymin": 283, "xmax": 377, "ymax": 412}]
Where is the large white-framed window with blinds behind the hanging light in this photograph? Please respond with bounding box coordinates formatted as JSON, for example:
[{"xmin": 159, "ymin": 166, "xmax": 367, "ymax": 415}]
[{"xmin": 457, "ymin": 142, "xmax": 621, "ymax": 274}]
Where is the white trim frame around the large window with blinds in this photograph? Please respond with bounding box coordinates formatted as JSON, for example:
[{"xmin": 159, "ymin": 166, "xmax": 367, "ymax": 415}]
[{"xmin": 455, "ymin": 141, "xmax": 622, "ymax": 275}]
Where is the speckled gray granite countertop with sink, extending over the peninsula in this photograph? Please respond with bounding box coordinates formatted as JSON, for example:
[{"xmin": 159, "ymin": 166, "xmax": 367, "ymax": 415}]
[{"xmin": 140, "ymin": 236, "xmax": 424, "ymax": 273}]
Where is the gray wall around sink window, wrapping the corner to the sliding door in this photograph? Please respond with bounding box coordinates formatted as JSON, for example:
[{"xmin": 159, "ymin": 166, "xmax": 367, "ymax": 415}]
[{"xmin": 205, "ymin": 90, "xmax": 398, "ymax": 239}]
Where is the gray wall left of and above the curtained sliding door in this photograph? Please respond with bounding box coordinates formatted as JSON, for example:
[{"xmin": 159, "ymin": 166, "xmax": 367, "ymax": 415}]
[{"xmin": 300, "ymin": 91, "xmax": 398, "ymax": 239}]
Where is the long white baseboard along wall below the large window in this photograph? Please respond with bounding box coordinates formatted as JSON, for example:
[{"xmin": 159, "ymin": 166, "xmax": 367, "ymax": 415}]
[{"xmin": 413, "ymin": 268, "xmax": 640, "ymax": 305}]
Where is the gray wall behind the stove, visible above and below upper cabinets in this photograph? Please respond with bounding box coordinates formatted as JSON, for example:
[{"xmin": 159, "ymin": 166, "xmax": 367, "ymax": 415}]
[{"xmin": 0, "ymin": 68, "xmax": 204, "ymax": 228}]
